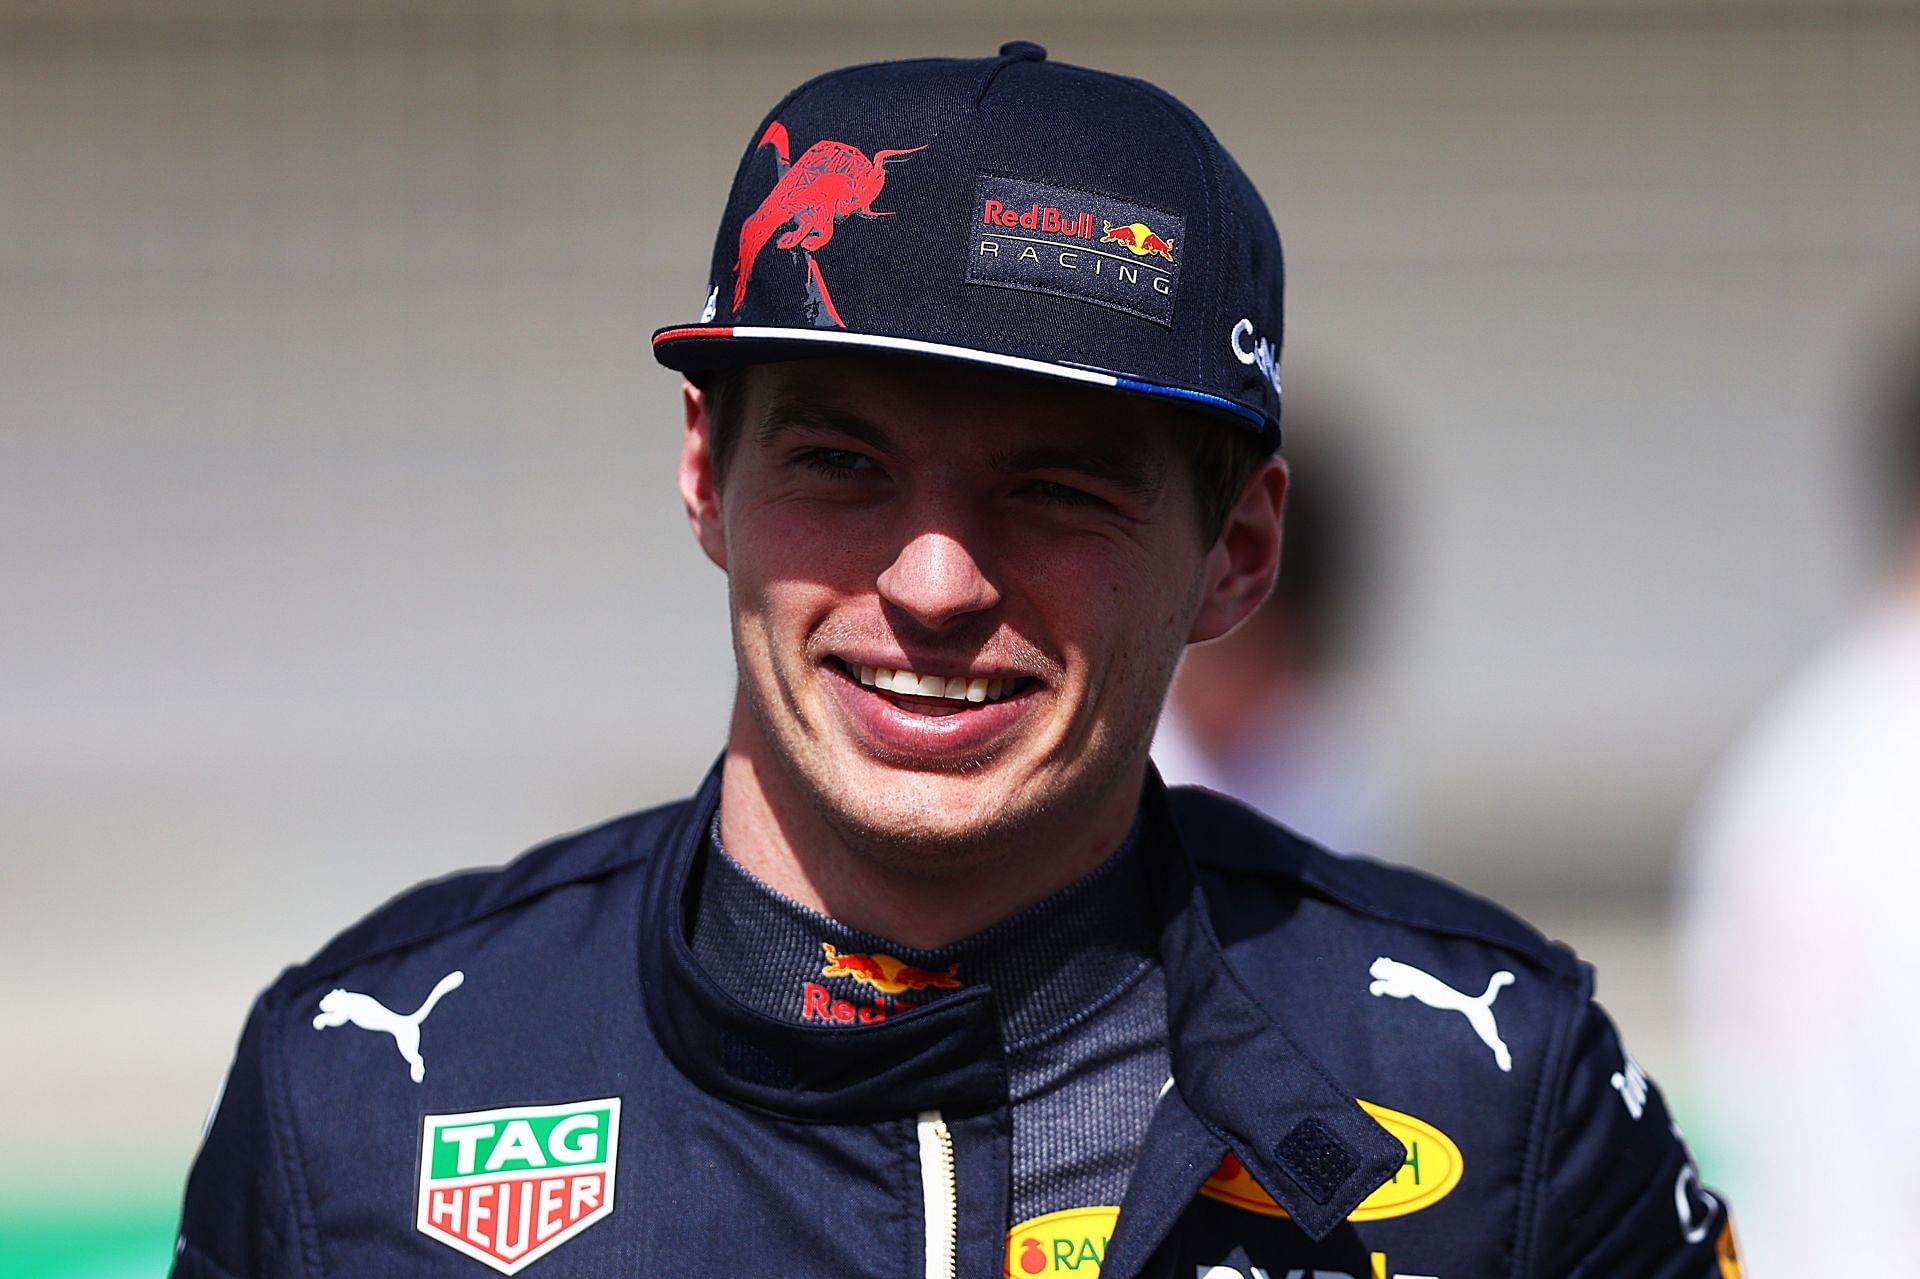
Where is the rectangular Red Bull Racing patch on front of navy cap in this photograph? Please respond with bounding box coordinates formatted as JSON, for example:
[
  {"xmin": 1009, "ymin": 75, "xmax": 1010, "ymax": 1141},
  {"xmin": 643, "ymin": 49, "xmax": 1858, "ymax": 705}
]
[{"xmin": 966, "ymin": 173, "xmax": 1187, "ymax": 328}]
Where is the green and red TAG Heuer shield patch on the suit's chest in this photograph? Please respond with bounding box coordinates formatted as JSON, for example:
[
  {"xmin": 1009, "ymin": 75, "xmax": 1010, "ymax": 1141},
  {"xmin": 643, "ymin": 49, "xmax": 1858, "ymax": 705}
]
[{"xmin": 415, "ymin": 1097, "xmax": 620, "ymax": 1275}]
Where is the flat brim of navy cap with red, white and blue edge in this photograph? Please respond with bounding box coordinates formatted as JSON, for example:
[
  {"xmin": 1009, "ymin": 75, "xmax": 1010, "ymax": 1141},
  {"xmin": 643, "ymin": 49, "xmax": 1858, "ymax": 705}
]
[{"xmin": 653, "ymin": 325, "xmax": 1281, "ymax": 449}]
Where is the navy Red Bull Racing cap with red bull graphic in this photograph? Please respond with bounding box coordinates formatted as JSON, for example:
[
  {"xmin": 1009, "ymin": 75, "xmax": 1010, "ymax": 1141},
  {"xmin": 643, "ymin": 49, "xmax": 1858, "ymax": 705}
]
[{"xmin": 653, "ymin": 40, "xmax": 1284, "ymax": 449}]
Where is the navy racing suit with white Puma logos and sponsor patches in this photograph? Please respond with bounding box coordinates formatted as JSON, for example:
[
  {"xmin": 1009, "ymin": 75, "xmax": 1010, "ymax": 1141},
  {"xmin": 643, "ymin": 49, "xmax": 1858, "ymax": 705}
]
[{"xmin": 175, "ymin": 770, "xmax": 1740, "ymax": 1279}]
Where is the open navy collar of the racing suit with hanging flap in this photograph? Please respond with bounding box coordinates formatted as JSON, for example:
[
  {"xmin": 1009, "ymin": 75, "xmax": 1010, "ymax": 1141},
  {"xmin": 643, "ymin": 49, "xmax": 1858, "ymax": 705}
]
[{"xmin": 641, "ymin": 766, "xmax": 1405, "ymax": 1244}]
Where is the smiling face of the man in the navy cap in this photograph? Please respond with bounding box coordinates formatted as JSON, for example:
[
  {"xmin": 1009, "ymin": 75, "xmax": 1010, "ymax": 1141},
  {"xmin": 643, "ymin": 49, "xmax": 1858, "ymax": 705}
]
[{"xmin": 682, "ymin": 359, "xmax": 1277, "ymax": 872}]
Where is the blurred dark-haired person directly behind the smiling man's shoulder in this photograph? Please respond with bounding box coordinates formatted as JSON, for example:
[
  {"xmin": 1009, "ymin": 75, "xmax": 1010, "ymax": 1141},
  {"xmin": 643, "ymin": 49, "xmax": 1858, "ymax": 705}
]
[{"xmin": 1154, "ymin": 422, "xmax": 1405, "ymax": 855}]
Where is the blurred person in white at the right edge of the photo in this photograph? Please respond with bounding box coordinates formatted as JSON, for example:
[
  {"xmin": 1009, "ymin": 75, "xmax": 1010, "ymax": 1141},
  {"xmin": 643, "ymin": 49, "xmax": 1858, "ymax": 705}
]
[{"xmin": 1680, "ymin": 303, "xmax": 1920, "ymax": 1275}]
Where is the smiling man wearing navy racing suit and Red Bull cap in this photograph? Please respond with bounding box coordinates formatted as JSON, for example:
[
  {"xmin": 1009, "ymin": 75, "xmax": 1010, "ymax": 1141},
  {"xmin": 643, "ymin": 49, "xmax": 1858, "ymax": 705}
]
[{"xmin": 177, "ymin": 44, "xmax": 1734, "ymax": 1279}]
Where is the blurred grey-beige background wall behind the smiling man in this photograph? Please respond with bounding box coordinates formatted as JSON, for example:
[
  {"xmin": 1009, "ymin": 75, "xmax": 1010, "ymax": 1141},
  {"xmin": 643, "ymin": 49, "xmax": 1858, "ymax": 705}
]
[{"xmin": 11, "ymin": 0, "xmax": 1920, "ymax": 1275}]
